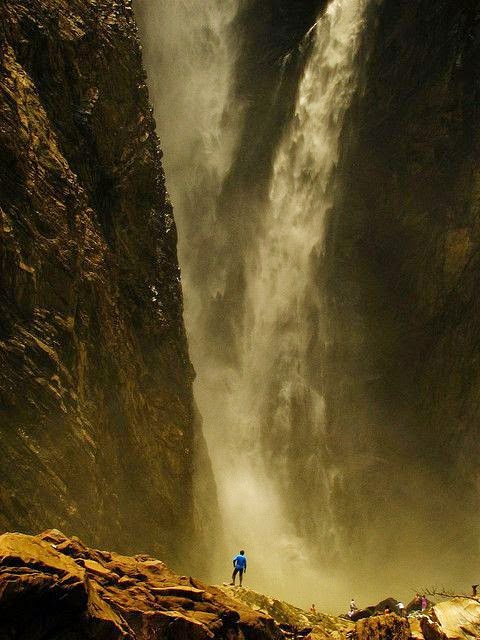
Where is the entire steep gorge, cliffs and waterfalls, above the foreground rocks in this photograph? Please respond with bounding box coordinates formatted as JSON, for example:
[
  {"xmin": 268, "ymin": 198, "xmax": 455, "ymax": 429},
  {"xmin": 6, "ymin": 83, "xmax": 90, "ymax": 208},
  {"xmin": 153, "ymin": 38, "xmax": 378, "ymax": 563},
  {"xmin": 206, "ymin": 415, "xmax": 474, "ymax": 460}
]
[{"xmin": 0, "ymin": 0, "xmax": 480, "ymax": 607}]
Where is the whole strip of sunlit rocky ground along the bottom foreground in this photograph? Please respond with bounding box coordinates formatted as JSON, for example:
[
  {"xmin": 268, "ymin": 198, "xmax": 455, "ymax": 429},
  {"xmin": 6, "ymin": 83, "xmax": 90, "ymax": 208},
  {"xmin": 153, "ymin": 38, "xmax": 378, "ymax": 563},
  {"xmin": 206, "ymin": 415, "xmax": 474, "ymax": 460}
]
[{"xmin": 0, "ymin": 529, "xmax": 480, "ymax": 640}]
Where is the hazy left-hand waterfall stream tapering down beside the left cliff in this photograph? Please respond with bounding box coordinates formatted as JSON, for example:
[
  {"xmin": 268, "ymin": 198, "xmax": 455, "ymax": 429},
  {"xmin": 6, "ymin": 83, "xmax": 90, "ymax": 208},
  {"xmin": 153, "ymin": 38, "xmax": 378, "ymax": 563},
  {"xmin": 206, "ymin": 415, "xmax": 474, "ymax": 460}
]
[{"xmin": 137, "ymin": 0, "xmax": 241, "ymax": 316}]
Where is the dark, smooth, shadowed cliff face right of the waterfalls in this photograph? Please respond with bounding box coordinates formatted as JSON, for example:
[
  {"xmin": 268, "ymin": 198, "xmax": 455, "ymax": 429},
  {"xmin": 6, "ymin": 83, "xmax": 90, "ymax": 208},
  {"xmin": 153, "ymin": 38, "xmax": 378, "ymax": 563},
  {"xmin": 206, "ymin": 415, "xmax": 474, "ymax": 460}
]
[{"xmin": 326, "ymin": 0, "xmax": 480, "ymax": 579}]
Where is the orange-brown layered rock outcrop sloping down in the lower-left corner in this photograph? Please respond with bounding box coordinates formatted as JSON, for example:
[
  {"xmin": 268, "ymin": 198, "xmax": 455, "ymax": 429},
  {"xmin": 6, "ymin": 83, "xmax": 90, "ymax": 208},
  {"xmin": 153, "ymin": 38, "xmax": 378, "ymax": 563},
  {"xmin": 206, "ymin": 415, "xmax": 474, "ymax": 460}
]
[{"xmin": 0, "ymin": 530, "xmax": 283, "ymax": 640}]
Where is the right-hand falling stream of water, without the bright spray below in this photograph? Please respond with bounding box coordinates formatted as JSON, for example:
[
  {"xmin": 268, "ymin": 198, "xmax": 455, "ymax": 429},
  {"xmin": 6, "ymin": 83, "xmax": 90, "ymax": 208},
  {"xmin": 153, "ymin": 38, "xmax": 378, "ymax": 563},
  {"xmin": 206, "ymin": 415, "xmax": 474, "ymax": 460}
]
[{"xmin": 243, "ymin": 0, "xmax": 372, "ymax": 543}]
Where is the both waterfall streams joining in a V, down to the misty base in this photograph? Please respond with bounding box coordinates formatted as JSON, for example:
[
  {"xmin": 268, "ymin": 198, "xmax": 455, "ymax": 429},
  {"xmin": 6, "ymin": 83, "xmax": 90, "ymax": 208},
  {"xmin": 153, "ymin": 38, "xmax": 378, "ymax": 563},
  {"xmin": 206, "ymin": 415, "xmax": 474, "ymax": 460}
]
[{"xmin": 135, "ymin": 0, "xmax": 367, "ymax": 606}]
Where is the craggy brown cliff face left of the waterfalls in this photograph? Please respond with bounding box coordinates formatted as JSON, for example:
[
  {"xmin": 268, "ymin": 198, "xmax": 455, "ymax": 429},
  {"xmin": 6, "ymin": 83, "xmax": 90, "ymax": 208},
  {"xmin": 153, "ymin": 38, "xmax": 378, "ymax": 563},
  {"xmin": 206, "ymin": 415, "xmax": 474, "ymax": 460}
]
[{"xmin": 0, "ymin": 0, "xmax": 212, "ymax": 561}]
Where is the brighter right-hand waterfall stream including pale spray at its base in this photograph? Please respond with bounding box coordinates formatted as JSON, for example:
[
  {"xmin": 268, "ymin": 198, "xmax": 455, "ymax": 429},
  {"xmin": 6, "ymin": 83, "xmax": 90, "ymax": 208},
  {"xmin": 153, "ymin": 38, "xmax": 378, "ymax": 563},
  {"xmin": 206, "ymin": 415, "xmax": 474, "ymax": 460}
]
[{"xmin": 207, "ymin": 0, "xmax": 372, "ymax": 607}]
